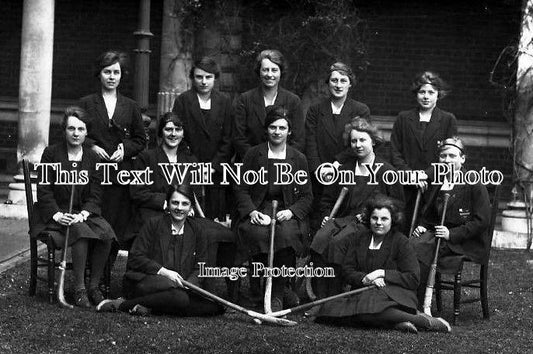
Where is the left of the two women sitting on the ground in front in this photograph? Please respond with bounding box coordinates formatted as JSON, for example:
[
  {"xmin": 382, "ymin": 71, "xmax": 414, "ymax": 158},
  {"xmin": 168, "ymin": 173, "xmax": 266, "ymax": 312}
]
[{"xmin": 96, "ymin": 184, "xmax": 224, "ymax": 316}]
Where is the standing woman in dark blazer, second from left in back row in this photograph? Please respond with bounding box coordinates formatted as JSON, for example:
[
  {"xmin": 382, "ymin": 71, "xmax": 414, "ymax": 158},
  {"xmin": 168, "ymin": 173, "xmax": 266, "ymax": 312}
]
[{"xmin": 173, "ymin": 57, "xmax": 233, "ymax": 221}]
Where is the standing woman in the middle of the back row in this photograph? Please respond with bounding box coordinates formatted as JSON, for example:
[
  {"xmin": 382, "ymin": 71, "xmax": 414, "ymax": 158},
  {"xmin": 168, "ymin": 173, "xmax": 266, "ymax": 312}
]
[{"xmin": 233, "ymin": 49, "xmax": 305, "ymax": 161}]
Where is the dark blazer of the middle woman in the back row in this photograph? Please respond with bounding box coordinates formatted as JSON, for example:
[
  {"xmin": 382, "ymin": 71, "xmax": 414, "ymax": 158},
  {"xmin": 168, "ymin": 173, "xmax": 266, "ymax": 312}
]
[{"xmin": 233, "ymin": 87, "xmax": 305, "ymax": 160}]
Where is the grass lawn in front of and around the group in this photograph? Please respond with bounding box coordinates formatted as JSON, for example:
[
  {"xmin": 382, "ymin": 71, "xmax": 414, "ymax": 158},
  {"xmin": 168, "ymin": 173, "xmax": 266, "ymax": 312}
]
[{"xmin": 0, "ymin": 250, "xmax": 533, "ymax": 353}]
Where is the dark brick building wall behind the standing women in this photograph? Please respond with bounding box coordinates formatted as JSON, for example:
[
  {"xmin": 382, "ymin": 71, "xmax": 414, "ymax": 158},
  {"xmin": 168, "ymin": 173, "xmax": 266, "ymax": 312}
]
[{"xmin": 0, "ymin": 0, "xmax": 521, "ymax": 196}]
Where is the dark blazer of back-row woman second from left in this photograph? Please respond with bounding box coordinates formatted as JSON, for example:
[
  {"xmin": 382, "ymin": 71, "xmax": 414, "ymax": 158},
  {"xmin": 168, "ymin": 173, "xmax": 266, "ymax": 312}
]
[{"xmin": 172, "ymin": 90, "xmax": 233, "ymax": 171}]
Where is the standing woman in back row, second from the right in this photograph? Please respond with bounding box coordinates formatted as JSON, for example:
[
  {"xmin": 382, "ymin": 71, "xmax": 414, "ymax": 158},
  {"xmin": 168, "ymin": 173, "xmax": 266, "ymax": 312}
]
[{"xmin": 305, "ymin": 62, "xmax": 370, "ymax": 231}]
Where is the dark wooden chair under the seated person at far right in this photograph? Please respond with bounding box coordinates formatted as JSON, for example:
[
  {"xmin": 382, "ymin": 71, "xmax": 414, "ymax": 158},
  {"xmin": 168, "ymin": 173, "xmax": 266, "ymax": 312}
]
[{"xmin": 435, "ymin": 185, "xmax": 501, "ymax": 324}]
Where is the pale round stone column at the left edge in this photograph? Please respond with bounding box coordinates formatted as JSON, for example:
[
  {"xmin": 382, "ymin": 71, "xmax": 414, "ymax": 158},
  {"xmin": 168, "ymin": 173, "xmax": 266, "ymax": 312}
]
[{"xmin": 0, "ymin": 0, "xmax": 55, "ymax": 213}]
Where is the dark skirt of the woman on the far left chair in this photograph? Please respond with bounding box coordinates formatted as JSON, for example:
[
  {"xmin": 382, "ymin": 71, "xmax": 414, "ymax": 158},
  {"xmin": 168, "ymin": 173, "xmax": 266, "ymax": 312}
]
[{"xmin": 42, "ymin": 215, "xmax": 116, "ymax": 247}]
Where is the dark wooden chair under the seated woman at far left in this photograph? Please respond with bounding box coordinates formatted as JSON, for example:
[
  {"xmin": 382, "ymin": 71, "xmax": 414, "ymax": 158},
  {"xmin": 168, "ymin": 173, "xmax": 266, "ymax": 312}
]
[{"xmin": 22, "ymin": 159, "xmax": 111, "ymax": 303}]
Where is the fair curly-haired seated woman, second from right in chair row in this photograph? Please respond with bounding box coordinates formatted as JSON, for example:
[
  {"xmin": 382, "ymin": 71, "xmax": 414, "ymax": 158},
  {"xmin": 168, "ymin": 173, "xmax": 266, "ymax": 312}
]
[{"xmin": 311, "ymin": 118, "xmax": 403, "ymax": 297}]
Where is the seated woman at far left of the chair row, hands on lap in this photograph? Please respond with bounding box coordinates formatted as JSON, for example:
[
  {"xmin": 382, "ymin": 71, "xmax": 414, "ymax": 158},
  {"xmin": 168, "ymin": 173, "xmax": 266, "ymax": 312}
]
[{"xmin": 31, "ymin": 107, "xmax": 116, "ymax": 308}]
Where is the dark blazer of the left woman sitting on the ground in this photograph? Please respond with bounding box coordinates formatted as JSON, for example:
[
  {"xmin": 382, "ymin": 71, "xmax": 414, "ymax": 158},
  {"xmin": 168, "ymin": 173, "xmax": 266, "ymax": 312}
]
[{"xmin": 125, "ymin": 214, "xmax": 207, "ymax": 284}]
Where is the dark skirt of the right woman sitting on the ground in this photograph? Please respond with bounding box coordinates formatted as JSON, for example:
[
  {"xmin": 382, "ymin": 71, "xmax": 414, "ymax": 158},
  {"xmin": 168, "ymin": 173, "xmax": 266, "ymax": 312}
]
[{"xmin": 318, "ymin": 284, "xmax": 416, "ymax": 317}]
